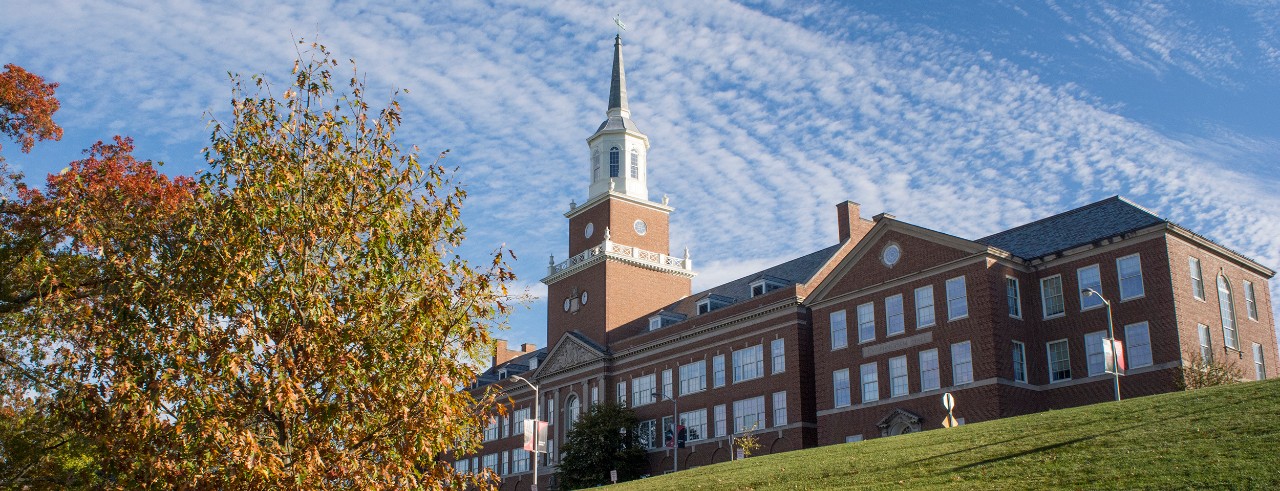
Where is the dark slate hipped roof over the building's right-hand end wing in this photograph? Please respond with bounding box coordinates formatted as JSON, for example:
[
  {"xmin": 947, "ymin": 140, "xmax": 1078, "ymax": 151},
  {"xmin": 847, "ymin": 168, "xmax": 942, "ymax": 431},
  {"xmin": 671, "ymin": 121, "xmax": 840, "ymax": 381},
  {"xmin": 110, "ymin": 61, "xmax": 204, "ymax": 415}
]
[{"xmin": 975, "ymin": 196, "xmax": 1166, "ymax": 260}]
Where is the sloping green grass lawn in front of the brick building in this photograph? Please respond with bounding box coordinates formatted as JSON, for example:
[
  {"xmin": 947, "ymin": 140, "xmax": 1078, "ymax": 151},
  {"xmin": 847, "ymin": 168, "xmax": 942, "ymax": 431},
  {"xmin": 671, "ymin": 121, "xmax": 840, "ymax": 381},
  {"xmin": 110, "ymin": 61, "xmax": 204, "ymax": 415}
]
[{"xmin": 606, "ymin": 380, "xmax": 1280, "ymax": 491}]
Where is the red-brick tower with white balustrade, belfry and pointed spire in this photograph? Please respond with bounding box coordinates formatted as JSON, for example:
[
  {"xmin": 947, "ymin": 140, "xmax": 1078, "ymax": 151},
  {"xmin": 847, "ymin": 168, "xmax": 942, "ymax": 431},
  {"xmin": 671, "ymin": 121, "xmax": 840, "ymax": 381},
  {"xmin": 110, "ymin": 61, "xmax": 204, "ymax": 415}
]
[{"xmin": 543, "ymin": 36, "xmax": 694, "ymax": 347}]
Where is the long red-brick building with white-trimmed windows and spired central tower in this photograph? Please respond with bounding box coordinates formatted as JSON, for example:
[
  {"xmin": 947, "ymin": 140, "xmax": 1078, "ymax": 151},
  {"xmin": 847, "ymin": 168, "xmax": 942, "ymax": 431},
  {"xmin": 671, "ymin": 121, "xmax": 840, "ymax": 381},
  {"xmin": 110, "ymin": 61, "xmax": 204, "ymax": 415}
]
[{"xmin": 457, "ymin": 36, "xmax": 1277, "ymax": 490}]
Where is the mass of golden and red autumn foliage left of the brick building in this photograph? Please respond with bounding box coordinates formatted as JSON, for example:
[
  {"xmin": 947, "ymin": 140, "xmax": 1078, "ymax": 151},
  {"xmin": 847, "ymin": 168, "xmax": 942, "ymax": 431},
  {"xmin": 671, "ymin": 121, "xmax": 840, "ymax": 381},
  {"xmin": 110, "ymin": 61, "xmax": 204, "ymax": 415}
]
[{"xmin": 0, "ymin": 45, "xmax": 513, "ymax": 488}]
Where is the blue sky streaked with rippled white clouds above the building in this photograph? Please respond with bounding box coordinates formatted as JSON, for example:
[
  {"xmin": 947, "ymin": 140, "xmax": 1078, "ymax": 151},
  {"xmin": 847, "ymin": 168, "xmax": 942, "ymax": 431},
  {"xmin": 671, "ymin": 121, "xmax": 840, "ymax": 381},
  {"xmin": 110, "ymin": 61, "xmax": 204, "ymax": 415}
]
[{"xmin": 0, "ymin": 0, "xmax": 1280, "ymax": 347}]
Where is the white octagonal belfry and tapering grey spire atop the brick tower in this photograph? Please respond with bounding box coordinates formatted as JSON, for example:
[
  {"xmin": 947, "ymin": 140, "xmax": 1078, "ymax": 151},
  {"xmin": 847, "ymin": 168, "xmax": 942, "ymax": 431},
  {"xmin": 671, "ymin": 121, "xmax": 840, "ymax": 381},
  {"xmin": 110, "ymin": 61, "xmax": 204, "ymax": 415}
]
[{"xmin": 586, "ymin": 35, "xmax": 649, "ymax": 199}]
